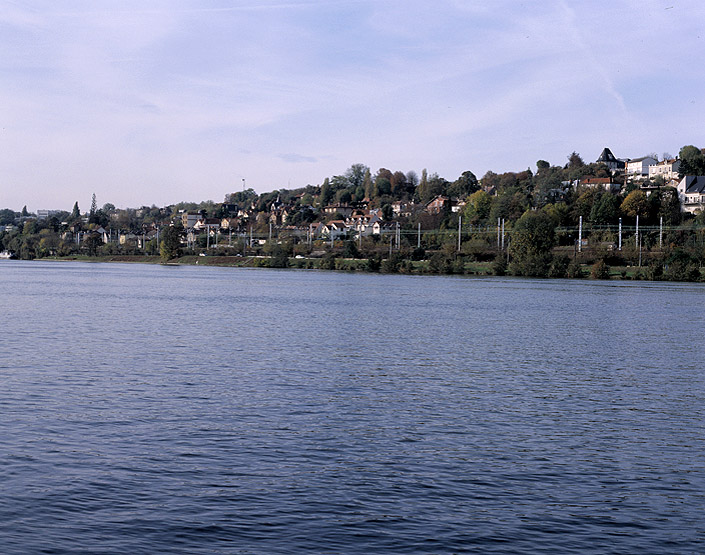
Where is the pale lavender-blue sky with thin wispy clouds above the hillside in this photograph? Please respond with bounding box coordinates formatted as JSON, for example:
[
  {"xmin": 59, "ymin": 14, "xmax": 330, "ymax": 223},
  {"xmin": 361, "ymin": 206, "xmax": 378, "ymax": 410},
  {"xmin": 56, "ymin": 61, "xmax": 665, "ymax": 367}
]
[{"xmin": 0, "ymin": 0, "xmax": 705, "ymax": 211}]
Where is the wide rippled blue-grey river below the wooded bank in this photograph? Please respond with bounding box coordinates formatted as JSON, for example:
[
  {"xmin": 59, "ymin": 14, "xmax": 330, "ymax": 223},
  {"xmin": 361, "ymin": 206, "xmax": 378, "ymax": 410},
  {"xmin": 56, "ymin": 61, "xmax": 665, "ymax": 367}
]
[{"xmin": 0, "ymin": 261, "xmax": 705, "ymax": 554}]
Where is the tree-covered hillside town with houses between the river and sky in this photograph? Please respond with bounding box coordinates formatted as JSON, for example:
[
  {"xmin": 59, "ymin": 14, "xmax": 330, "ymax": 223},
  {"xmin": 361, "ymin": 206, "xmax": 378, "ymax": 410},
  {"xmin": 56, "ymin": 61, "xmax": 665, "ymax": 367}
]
[{"xmin": 0, "ymin": 145, "xmax": 705, "ymax": 279}]
